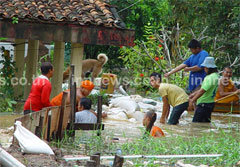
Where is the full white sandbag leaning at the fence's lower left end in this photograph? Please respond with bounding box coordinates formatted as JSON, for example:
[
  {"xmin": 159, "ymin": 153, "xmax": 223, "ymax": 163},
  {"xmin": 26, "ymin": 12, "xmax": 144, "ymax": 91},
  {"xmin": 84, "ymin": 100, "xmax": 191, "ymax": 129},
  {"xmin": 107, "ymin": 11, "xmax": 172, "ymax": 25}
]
[{"xmin": 14, "ymin": 121, "xmax": 54, "ymax": 155}]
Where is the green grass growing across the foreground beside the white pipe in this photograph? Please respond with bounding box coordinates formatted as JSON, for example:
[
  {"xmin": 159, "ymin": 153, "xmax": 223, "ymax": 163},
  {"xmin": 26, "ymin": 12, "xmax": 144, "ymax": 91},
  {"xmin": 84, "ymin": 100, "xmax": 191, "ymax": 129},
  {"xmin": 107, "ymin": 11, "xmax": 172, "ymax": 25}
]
[{"xmin": 53, "ymin": 129, "xmax": 240, "ymax": 167}]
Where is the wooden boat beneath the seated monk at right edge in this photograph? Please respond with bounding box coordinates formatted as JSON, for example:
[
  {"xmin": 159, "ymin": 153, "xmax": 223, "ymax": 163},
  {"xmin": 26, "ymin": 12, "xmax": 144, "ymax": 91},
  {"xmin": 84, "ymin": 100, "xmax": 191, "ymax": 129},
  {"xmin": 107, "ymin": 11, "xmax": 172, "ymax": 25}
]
[{"xmin": 213, "ymin": 103, "xmax": 240, "ymax": 114}]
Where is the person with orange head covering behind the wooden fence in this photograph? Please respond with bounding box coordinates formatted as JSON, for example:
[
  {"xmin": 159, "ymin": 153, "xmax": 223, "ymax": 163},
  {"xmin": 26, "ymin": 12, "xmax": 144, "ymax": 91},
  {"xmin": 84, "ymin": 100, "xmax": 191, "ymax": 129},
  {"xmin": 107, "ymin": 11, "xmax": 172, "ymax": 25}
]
[{"xmin": 51, "ymin": 80, "xmax": 94, "ymax": 106}]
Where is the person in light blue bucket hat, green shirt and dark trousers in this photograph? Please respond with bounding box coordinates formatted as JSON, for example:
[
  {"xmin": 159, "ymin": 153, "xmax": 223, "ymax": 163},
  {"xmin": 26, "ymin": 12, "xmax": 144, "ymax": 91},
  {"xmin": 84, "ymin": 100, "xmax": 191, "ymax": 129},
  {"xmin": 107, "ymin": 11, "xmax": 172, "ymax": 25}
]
[{"xmin": 189, "ymin": 57, "xmax": 219, "ymax": 122}]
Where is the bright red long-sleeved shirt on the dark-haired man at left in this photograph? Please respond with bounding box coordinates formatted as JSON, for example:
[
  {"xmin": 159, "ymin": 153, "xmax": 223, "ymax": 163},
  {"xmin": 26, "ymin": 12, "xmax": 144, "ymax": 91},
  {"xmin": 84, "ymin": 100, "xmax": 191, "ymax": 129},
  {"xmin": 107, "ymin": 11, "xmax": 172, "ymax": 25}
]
[{"xmin": 24, "ymin": 75, "xmax": 52, "ymax": 111}]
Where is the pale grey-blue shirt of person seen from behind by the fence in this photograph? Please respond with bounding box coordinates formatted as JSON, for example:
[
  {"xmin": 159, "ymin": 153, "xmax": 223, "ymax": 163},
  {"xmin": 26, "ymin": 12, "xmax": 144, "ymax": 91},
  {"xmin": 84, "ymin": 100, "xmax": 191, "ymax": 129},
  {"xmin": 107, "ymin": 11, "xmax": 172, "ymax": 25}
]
[{"xmin": 75, "ymin": 110, "xmax": 97, "ymax": 124}]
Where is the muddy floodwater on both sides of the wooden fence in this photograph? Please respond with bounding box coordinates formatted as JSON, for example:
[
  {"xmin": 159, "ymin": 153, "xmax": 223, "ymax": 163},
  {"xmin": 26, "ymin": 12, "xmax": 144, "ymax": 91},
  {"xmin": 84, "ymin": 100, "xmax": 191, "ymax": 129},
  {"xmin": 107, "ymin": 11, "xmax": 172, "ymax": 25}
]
[{"xmin": 0, "ymin": 113, "xmax": 240, "ymax": 146}]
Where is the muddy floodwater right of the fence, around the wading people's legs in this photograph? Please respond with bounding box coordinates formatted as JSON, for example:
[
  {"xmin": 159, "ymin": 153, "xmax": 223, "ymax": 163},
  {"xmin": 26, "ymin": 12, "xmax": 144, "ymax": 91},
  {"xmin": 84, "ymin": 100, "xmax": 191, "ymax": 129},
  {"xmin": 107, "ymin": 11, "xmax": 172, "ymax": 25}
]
[{"xmin": 104, "ymin": 113, "xmax": 240, "ymax": 138}]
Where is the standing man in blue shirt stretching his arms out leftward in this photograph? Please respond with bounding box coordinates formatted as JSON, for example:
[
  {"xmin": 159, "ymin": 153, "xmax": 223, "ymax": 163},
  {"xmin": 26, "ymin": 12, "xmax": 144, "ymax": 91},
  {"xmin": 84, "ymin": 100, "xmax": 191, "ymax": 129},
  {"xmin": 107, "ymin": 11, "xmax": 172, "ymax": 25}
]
[{"xmin": 164, "ymin": 39, "xmax": 209, "ymax": 92}]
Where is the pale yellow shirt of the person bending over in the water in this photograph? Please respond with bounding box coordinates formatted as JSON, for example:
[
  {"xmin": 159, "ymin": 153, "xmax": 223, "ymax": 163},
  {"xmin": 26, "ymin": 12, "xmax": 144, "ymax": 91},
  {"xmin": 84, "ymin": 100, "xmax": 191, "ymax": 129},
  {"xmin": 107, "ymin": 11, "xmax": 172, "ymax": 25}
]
[{"xmin": 158, "ymin": 83, "xmax": 188, "ymax": 107}]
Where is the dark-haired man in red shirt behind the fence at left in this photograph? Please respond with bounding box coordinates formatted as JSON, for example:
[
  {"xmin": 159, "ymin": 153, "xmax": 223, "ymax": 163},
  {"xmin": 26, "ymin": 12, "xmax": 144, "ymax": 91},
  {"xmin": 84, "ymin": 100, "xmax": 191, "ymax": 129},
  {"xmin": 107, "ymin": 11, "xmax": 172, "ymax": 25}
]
[{"xmin": 24, "ymin": 62, "xmax": 53, "ymax": 115}]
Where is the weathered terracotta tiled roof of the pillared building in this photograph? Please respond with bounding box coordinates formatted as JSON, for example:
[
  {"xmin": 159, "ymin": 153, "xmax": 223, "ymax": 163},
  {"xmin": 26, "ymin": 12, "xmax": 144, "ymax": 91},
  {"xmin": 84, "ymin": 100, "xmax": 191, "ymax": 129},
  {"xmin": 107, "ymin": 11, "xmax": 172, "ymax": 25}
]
[{"xmin": 0, "ymin": 0, "xmax": 125, "ymax": 28}]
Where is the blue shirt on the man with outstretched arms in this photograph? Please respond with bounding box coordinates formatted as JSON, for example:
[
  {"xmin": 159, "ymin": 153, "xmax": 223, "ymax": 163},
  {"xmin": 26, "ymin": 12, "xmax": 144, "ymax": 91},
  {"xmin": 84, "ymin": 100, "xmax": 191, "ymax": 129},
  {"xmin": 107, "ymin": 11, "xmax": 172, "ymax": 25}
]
[{"xmin": 183, "ymin": 50, "xmax": 209, "ymax": 91}]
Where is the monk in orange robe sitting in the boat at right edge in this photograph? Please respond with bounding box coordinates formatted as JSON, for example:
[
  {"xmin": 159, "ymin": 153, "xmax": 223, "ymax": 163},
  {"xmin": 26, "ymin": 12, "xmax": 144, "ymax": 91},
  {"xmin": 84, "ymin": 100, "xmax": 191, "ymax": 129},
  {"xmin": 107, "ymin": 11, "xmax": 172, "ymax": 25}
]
[{"xmin": 215, "ymin": 67, "xmax": 240, "ymax": 103}]
